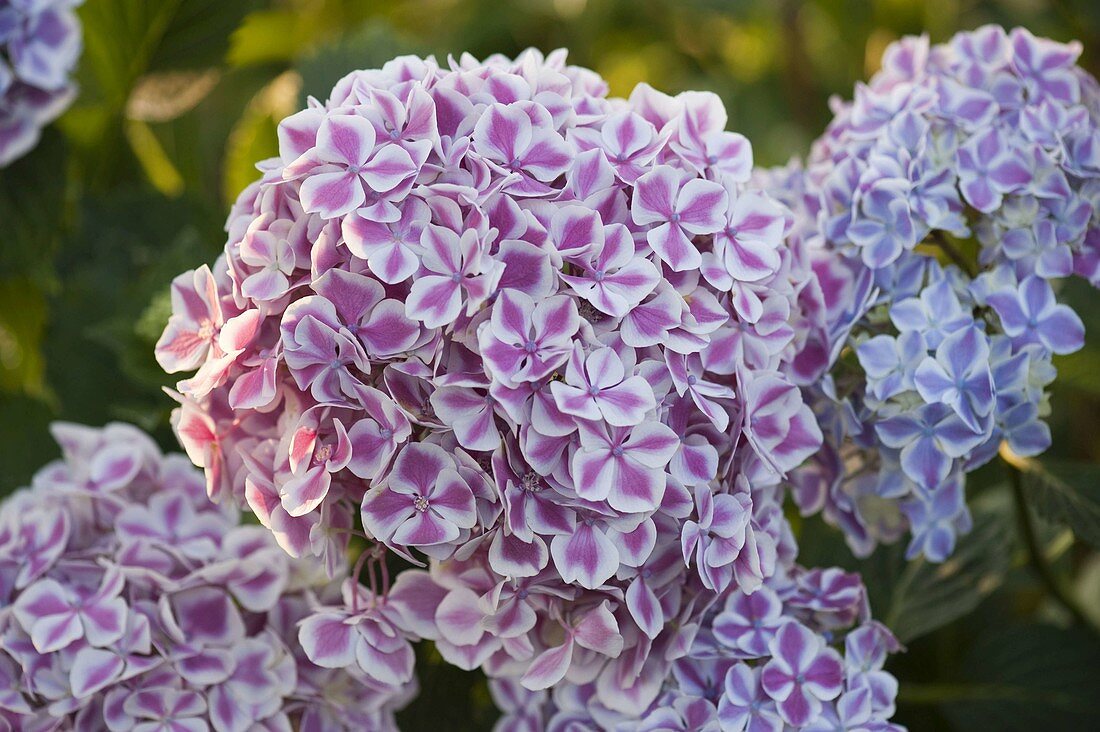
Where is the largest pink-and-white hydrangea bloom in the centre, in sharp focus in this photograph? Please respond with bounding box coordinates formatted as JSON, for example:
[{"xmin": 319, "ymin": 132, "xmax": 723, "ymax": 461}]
[{"xmin": 150, "ymin": 51, "xmax": 893, "ymax": 725}]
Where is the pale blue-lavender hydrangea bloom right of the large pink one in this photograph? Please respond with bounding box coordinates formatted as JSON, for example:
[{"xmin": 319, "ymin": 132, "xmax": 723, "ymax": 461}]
[{"xmin": 765, "ymin": 26, "xmax": 1100, "ymax": 561}]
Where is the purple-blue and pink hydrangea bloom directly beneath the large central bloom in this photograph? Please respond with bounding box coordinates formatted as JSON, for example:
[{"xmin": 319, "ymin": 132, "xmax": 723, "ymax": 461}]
[{"xmin": 442, "ymin": 545, "xmax": 902, "ymax": 732}]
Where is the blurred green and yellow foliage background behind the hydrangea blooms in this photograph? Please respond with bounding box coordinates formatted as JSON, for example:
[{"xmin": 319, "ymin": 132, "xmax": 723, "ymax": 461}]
[{"xmin": 0, "ymin": 0, "xmax": 1100, "ymax": 732}]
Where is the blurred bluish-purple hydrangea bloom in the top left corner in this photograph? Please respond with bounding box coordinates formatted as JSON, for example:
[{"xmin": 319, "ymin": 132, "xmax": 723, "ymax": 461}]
[{"xmin": 0, "ymin": 0, "xmax": 83, "ymax": 167}]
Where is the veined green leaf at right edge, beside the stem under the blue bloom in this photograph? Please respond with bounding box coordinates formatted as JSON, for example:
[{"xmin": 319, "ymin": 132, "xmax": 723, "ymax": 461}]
[{"xmin": 1019, "ymin": 460, "xmax": 1100, "ymax": 548}]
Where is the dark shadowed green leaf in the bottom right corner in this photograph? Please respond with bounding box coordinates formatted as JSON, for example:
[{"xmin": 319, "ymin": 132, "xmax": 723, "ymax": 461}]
[{"xmin": 932, "ymin": 623, "xmax": 1100, "ymax": 732}]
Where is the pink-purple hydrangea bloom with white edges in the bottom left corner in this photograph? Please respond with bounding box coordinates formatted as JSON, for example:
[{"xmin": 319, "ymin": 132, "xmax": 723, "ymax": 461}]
[{"xmin": 0, "ymin": 424, "xmax": 416, "ymax": 732}]
